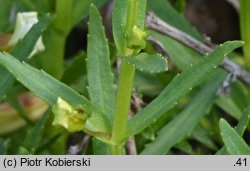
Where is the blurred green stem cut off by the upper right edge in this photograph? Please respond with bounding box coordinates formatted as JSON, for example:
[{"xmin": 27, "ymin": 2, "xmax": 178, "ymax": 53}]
[{"xmin": 240, "ymin": 0, "xmax": 250, "ymax": 65}]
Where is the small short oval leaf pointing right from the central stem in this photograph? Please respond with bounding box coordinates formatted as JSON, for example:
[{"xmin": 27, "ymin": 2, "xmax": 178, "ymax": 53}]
[{"xmin": 123, "ymin": 53, "xmax": 168, "ymax": 73}]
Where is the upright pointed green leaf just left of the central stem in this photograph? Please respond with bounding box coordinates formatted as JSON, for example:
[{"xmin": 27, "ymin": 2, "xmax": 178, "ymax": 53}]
[{"xmin": 87, "ymin": 4, "xmax": 115, "ymax": 121}]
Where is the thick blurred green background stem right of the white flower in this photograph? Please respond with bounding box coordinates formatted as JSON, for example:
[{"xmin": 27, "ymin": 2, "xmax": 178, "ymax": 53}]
[{"xmin": 39, "ymin": 0, "xmax": 73, "ymax": 79}]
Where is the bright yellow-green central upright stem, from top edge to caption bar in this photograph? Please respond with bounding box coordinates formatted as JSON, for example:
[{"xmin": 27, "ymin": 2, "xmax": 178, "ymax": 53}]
[{"xmin": 111, "ymin": 0, "xmax": 139, "ymax": 154}]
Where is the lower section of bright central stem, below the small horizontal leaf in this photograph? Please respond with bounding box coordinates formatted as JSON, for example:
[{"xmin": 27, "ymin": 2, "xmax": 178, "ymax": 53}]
[{"xmin": 111, "ymin": 60, "xmax": 135, "ymax": 154}]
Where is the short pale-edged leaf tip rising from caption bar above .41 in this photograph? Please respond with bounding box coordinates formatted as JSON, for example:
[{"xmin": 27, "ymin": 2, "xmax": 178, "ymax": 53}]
[{"xmin": 220, "ymin": 119, "xmax": 250, "ymax": 155}]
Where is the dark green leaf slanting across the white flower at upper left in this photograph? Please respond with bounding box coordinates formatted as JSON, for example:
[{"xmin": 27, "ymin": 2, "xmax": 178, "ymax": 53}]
[{"xmin": 0, "ymin": 14, "xmax": 52, "ymax": 99}]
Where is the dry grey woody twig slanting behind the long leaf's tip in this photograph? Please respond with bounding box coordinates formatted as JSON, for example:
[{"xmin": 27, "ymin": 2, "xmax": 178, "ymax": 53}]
[{"xmin": 146, "ymin": 12, "xmax": 250, "ymax": 86}]
